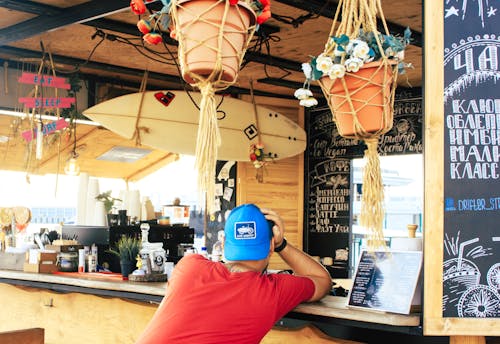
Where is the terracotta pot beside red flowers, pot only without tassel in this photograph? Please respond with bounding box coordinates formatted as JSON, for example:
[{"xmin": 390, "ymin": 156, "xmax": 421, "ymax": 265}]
[{"xmin": 174, "ymin": 0, "xmax": 256, "ymax": 84}]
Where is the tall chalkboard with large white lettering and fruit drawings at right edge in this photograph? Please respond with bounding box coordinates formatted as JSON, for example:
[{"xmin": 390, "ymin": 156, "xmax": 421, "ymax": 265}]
[{"xmin": 443, "ymin": 1, "xmax": 500, "ymax": 318}]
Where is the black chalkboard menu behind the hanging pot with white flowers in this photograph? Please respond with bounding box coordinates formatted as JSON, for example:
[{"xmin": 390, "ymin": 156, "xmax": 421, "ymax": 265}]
[{"xmin": 304, "ymin": 88, "xmax": 423, "ymax": 277}]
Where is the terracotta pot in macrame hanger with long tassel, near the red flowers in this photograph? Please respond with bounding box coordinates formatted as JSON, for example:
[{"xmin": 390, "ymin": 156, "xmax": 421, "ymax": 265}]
[{"xmin": 171, "ymin": 0, "xmax": 256, "ymax": 214}]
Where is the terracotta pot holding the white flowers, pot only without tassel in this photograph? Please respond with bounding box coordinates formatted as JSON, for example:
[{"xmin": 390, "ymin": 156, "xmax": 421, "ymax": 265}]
[{"xmin": 319, "ymin": 62, "xmax": 395, "ymax": 137}]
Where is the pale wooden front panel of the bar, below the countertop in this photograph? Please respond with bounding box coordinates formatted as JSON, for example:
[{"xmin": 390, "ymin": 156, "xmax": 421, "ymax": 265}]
[{"xmin": 0, "ymin": 283, "xmax": 357, "ymax": 344}]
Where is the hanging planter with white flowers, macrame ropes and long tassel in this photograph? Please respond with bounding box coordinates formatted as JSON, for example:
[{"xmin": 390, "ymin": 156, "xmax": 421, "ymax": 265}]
[{"xmin": 295, "ymin": 0, "xmax": 411, "ymax": 249}]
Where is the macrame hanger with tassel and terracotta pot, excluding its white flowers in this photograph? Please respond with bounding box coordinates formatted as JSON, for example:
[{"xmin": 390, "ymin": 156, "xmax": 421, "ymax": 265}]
[{"xmin": 319, "ymin": 0, "xmax": 398, "ymax": 250}]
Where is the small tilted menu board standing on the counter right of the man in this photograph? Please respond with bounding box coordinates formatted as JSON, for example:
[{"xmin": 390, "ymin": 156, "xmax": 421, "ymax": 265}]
[{"xmin": 348, "ymin": 251, "xmax": 423, "ymax": 314}]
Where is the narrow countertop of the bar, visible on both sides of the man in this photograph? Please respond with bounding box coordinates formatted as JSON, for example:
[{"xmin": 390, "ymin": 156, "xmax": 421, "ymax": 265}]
[{"xmin": 0, "ymin": 270, "xmax": 420, "ymax": 332}]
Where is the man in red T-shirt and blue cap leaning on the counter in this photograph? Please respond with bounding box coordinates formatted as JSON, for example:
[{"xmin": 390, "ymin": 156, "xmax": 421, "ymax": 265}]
[{"xmin": 137, "ymin": 204, "xmax": 331, "ymax": 344}]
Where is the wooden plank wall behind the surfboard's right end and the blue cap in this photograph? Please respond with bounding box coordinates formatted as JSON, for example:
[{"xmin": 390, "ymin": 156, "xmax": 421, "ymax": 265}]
[{"xmin": 236, "ymin": 97, "xmax": 304, "ymax": 269}]
